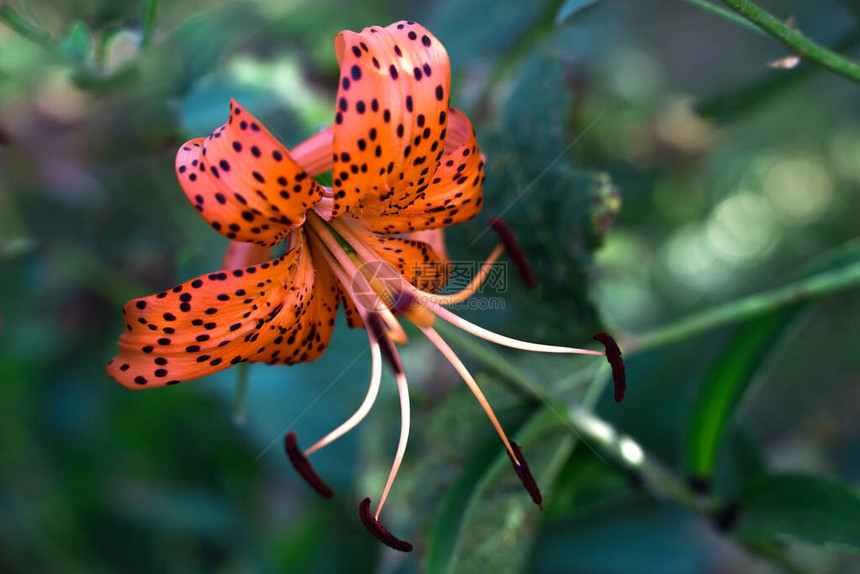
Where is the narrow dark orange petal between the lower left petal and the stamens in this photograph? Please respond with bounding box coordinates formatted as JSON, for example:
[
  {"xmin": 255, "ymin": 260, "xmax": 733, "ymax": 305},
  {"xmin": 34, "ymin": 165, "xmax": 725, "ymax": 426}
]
[{"xmin": 249, "ymin": 237, "xmax": 339, "ymax": 365}]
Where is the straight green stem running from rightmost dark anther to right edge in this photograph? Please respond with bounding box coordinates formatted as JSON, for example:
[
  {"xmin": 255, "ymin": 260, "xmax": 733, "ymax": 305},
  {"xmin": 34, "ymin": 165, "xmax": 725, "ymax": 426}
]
[{"xmin": 620, "ymin": 263, "xmax": 860, "ymax": 353}]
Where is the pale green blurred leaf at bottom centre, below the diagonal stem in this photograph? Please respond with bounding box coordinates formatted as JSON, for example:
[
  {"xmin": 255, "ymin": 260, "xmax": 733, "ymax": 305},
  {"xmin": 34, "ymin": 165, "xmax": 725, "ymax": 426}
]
[{"xmin": 427, "ymin": 408, "xmax": 575, "ymax": 574}]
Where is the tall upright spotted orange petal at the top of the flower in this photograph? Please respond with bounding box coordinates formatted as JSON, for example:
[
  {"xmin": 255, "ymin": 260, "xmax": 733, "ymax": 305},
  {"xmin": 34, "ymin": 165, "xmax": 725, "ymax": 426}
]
[{"xmin": 332, "ymin": 22, "xmax": 451, "ymax": 216}]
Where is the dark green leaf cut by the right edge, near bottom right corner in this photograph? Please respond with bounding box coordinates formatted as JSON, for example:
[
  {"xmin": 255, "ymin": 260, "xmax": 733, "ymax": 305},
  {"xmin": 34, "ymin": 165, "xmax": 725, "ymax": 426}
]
[{"xmin": 736, "ymin": 474, "xmax": 860, "ymax": 553}]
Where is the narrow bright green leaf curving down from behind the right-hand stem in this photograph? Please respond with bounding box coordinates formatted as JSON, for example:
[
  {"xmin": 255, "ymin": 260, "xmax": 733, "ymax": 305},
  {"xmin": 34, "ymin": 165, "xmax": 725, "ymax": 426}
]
[{"xmin": 684, "ymin": 241, "xmax": 860, "ymax": 479}]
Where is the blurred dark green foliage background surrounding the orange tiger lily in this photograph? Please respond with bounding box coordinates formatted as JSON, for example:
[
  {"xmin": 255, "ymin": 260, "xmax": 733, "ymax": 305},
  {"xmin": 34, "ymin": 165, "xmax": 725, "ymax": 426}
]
[{"xmin": 0, "ymin": 0, "xmax": 860, "ymax": 574}]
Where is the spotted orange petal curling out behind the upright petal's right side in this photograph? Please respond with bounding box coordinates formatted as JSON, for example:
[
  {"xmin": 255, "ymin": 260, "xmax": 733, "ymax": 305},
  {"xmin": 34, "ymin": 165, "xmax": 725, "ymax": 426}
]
[{"xmin": 352, "ymin": 108, "xmax": 484, "ymax": 234}]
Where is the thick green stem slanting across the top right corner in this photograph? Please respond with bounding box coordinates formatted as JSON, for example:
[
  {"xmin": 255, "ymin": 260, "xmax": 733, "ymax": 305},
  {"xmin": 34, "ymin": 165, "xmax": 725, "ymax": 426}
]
[{"xmin": 720, "ymin": 0, "xmax": 860, "ymax": 84}]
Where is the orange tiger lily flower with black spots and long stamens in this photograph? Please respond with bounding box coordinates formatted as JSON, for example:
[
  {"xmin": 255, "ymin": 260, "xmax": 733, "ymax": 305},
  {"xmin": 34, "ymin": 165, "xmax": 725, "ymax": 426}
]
[{"xmin": 107, "ymin": 22, "xmax": 620, "ymax": 551}]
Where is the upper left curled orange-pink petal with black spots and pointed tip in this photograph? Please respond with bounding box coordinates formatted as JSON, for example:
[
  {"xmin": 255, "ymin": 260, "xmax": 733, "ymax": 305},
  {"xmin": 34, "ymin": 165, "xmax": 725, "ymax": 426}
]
[{"xmin": 176, "ymin": 100, "xmax": 323, "ymax": 246}]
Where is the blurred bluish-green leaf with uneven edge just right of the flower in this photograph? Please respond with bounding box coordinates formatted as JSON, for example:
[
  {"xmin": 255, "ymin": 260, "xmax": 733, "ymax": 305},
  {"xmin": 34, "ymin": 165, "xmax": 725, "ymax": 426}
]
[{"xmin": 482, "ymin": 53, "xmax": 620, "ymax": 340}]
